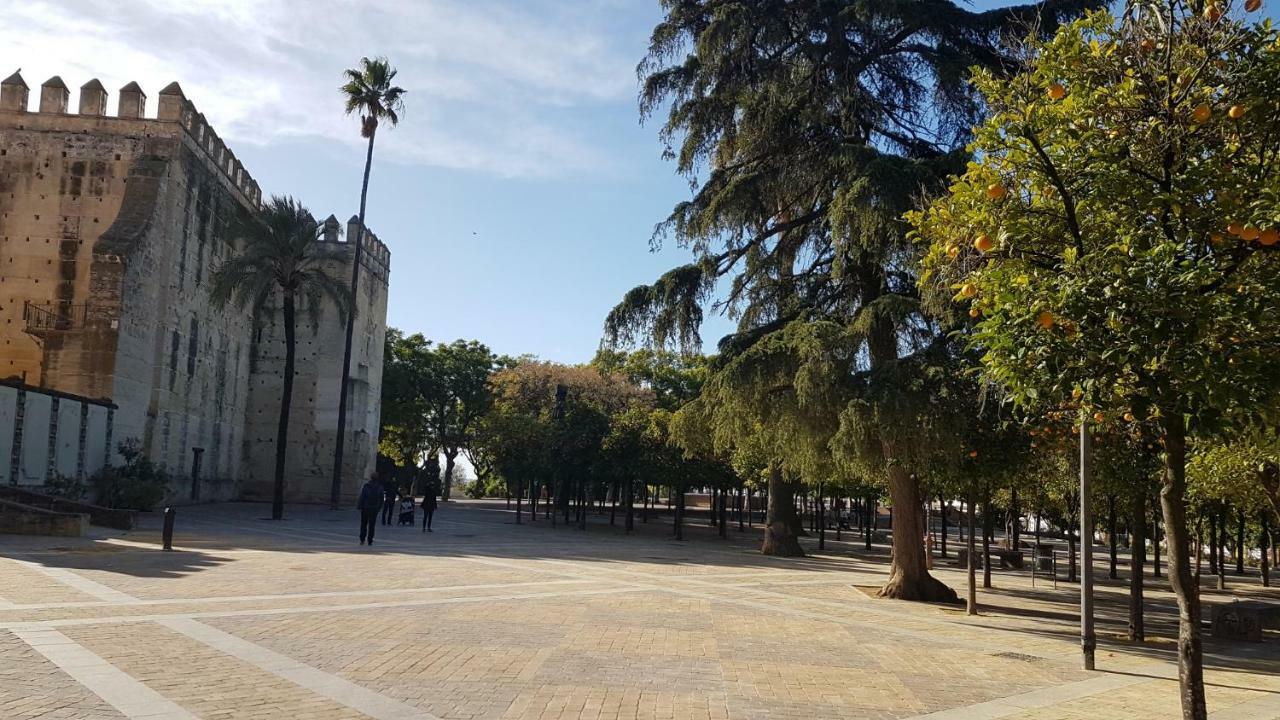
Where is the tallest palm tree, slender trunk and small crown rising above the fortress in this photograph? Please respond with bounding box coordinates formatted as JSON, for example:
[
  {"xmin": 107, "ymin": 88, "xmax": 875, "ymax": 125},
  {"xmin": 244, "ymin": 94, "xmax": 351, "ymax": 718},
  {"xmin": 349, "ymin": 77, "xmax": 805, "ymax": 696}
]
[{"xmin": 329, "ymin": 58, "xmax": 404, "ymax": 510}]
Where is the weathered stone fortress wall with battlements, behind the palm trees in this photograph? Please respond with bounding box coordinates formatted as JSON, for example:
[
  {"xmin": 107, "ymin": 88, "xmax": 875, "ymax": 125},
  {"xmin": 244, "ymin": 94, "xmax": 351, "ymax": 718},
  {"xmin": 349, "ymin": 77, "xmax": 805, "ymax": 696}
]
[{"xmin": 0, "ymin": 73, "xmax": 390, "ymax": 500}]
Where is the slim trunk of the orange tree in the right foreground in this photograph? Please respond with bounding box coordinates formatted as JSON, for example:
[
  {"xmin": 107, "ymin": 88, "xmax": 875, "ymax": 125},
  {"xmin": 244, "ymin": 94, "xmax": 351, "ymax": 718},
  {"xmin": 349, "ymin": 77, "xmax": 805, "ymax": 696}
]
[{"xmin": 1160, "ymin": 410, "xmax": 1207, "ymax": 720}]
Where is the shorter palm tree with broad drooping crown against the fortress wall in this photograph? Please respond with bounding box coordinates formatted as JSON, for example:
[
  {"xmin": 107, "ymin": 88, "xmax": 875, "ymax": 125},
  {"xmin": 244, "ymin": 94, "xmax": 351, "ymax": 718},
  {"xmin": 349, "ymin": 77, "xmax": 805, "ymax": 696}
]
[{"xmin": 209, "ymin": 196, "xmax": 352, "ymax": 520}]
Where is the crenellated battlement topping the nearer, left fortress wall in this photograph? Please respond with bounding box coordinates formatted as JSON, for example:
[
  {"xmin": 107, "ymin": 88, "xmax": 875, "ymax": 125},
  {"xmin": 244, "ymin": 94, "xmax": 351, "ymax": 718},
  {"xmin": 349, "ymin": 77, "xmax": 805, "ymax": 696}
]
[{"xmin": 0, "ymin": 73, "xmax": 262, "ymax": 208}]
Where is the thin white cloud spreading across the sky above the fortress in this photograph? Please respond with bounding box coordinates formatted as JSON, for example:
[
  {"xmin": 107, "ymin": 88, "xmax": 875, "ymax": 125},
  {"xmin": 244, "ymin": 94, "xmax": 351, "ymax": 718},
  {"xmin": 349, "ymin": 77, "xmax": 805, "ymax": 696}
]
[{"xmin": 0, "ymin": 0, "xmax": 636, "ymax": 176}]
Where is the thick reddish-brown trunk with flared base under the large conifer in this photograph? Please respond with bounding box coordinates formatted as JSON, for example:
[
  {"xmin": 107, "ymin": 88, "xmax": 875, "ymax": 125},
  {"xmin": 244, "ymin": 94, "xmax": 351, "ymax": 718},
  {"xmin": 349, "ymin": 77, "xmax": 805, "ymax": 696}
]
[{"xmin": 876, "ymin": 453, "xmax": 959, "ymax": 602}]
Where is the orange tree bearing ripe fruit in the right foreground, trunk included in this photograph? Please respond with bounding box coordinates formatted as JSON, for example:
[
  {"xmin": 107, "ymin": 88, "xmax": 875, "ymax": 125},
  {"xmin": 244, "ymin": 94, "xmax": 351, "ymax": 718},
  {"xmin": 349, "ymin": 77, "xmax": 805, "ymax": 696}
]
[{"xmin": 910, "ymin": 0, "xmax": 1280, "ymax": 717}]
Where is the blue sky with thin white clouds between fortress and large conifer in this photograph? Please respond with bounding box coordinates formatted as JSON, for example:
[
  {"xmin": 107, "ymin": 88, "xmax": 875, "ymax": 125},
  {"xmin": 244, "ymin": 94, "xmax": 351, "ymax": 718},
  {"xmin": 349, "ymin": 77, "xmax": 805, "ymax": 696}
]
[{"xmin": 0, "ymin": 0, "xmax": 1274, "ymax": 363}]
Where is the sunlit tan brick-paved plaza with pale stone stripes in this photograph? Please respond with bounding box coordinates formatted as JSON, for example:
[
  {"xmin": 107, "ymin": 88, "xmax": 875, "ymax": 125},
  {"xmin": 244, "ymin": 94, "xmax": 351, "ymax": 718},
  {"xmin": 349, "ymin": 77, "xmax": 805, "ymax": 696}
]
[{"xmin": 0, "ymin": 501, "xmax": 1280, "ymax": 720}]
